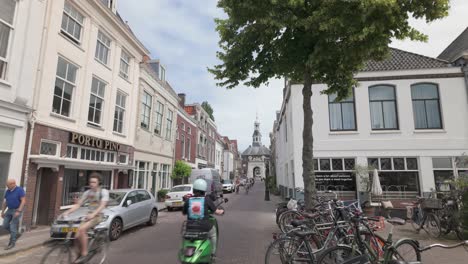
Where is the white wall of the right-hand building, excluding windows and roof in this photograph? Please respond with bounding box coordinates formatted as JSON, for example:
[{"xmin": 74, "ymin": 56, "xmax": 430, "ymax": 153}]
[{"xmin": 274, "ymin": 68, "xmax": 468, "ymax": 194}]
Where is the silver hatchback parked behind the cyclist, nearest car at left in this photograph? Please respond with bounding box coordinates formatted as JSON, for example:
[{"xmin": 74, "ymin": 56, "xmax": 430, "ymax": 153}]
[{"xmin": 50, "ymin": 189, "xmax": 158, "ymax": 240}]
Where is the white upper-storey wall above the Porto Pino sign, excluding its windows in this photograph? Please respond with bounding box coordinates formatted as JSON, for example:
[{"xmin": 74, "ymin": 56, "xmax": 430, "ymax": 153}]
[{"xmin": 34, "ymin": 0, "xmax": 148, "ymax": 148}]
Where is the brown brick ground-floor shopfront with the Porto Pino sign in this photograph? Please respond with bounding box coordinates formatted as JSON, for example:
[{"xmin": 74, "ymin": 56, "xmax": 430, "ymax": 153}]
[{"xmin": 23, "ymin": 123, "xmax": 134, "ymax": 227}]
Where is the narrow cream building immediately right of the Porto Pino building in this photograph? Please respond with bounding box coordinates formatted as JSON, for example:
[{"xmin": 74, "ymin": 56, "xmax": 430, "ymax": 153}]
[{"xmin": 134, "ymin": 58, "xmax": 179, "ymax": 195}]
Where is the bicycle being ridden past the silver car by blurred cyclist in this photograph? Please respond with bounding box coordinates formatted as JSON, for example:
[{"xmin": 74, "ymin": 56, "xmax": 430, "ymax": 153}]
[{"xmin": 41, "ymin": 217, "xmax": 110, "ymax": 264}]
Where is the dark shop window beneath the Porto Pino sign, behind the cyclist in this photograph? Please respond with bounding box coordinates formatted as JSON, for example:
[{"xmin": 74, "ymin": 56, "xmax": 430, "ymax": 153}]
[{"xmin": 62, "ymin": 169, "xmax": 111, "ymax": 206}]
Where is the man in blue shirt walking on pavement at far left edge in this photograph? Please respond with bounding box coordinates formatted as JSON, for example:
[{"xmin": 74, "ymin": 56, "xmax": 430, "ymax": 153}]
[{"xmin": 2, "ymin": 179, "xmax": 26, "ymax": 250}]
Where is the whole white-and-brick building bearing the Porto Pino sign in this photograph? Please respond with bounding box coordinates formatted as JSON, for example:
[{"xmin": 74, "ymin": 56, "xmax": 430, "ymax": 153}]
[{"xmin": 22, "ymin": 0, "xmax": 149, "ymax": 226}]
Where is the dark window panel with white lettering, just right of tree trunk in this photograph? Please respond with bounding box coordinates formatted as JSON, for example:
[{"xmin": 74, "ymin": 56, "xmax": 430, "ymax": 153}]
[{"xmin": 315, "ymin": 172, "xmax": 356, "ymax": 191}]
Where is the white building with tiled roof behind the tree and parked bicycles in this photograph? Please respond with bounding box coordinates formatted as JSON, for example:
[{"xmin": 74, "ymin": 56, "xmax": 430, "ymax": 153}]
[{"xmin": 273, "ymin": 48, "xmax": 468, "ymax": 200}]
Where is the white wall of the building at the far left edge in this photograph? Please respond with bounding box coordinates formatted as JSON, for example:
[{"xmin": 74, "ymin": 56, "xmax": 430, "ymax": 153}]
[{"xmin": 0, "ymin": 0, "xmax": 46, "ymax": 224}]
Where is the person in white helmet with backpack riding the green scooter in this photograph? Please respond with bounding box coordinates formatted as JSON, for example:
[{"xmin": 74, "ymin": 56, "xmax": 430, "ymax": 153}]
[{"xmin": 182, "ymin": 179, "xmax": 224, "ymax": 257}]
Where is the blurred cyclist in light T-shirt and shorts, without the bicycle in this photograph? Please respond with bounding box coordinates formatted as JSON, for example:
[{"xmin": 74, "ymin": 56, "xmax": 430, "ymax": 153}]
[{"xmin": 62, "ymin": 172, "xmax": 109, "ymax": 263}]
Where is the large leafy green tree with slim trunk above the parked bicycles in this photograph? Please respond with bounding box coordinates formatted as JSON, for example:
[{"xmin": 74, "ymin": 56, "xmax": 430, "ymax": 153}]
[{"xmin": 209, "ymin": 0, "xmax": 449, "ymax": 208}]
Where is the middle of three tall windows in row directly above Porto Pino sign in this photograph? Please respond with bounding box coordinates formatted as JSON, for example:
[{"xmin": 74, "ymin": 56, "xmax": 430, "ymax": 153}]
[{"xmin": 88, "ymin": 77, "xmax": 106, "ymax": 126}]
